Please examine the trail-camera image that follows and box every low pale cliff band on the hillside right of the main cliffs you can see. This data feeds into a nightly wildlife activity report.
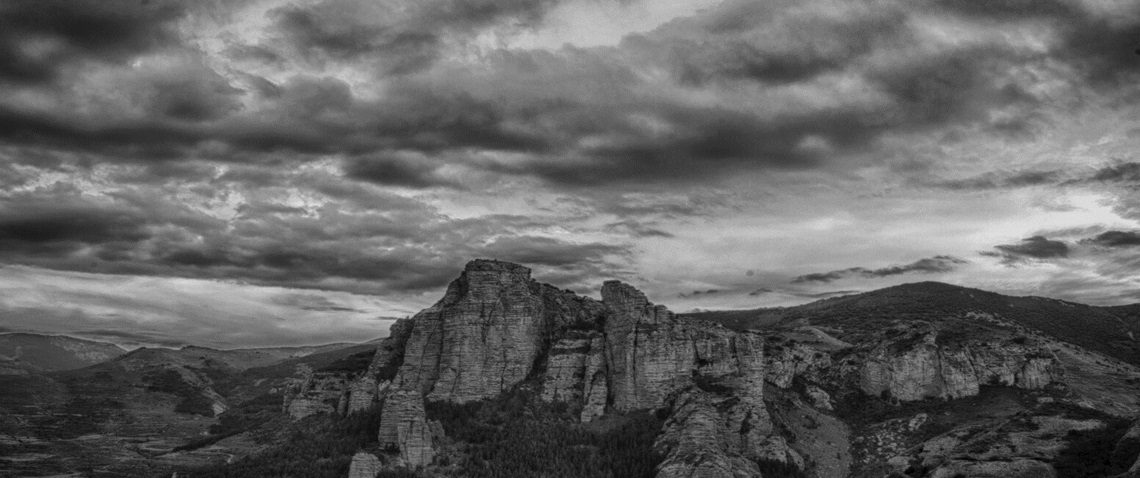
[860,332,1060,400]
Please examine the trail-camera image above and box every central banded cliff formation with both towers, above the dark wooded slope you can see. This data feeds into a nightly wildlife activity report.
[367,260,793,474]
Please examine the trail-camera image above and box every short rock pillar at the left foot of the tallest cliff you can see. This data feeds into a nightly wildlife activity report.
[378,390,435,468]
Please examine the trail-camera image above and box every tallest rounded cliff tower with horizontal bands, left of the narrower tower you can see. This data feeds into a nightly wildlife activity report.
[393,260,601,403]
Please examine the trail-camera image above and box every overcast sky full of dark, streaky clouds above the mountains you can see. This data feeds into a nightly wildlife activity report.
[0,0,1140,347]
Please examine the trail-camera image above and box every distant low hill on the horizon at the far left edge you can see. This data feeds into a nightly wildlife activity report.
[0,333,127,375]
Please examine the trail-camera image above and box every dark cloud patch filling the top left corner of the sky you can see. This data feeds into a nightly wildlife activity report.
[0,0,185,82]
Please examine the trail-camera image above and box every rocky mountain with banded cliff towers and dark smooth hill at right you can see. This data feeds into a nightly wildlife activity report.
[337,261,1140,477]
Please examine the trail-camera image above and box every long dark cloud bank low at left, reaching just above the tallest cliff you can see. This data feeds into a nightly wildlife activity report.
[0,173,629,296]
